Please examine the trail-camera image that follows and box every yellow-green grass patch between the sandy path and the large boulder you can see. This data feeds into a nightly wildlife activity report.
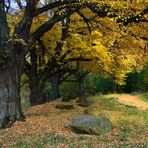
[85,96,148,126]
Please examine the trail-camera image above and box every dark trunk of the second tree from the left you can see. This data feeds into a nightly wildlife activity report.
[25,47,46,106]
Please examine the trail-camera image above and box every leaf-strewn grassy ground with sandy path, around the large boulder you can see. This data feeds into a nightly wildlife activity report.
[0,94,148,148]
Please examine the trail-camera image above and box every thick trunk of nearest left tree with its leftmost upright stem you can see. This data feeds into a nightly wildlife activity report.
[0,1,23,127]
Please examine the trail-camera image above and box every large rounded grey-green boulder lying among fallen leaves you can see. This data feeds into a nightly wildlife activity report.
[70,115,112,135]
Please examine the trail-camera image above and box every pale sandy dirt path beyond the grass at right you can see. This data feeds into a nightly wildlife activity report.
[108,94,148,110]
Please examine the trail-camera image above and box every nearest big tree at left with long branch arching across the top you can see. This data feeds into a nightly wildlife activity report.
[0,0,148,126]
